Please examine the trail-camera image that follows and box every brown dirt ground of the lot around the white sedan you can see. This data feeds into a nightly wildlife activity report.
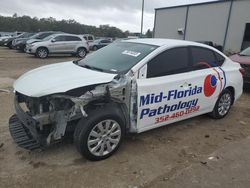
[0,47,250,188]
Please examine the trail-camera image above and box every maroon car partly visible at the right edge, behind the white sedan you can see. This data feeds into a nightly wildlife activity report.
[230,47,250,84]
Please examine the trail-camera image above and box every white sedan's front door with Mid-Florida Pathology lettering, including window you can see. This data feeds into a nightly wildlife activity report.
[137,47,222,132]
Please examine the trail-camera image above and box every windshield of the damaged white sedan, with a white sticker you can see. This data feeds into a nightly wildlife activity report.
[78,42,157,73]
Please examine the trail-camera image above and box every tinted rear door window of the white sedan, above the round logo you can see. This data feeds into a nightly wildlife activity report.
[191,47,217,70]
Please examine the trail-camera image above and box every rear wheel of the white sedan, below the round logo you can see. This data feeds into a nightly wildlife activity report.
[210,89,233,119]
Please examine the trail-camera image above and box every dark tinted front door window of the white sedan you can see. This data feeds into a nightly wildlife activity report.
[147,47,189,78]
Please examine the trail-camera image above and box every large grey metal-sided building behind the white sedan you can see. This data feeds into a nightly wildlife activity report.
[154,0,250,52]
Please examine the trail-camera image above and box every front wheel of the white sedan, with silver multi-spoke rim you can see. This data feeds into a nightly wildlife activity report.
[74,106,125,161]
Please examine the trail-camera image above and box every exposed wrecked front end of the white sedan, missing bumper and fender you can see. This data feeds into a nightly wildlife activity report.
[9,75,135,150]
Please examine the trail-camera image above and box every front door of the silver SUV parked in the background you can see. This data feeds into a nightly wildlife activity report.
[49,35,66,53]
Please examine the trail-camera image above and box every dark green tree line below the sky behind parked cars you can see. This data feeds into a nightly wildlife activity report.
[0,14,152,38]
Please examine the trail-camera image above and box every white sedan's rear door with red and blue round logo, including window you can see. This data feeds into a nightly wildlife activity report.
[189,46,225,112]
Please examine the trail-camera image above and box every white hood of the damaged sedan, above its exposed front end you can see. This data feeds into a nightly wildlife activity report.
[13,62,116,97]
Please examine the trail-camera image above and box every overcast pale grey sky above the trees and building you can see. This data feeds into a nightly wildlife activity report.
[0,0,218,32]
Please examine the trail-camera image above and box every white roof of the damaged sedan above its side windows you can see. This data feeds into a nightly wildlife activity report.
[122,38,211,48]
